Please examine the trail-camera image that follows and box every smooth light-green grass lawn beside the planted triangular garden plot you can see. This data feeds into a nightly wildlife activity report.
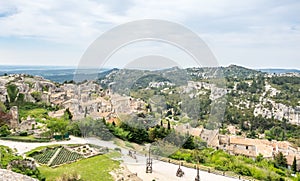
[39,155,120,181]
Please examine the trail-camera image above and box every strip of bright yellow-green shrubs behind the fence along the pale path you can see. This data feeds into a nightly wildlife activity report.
[170,148,290,180]
